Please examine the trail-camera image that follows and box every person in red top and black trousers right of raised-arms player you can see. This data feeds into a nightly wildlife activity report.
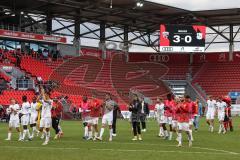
[51,99,63,139]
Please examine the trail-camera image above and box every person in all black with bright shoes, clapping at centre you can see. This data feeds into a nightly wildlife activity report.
[129,94,142,141]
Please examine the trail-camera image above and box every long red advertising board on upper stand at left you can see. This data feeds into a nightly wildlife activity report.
[0,29,67,43]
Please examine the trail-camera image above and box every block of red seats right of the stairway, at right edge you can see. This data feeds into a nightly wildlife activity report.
[192,62,240,96]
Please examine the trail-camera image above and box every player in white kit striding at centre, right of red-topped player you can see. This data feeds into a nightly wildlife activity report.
[97,94,115,141]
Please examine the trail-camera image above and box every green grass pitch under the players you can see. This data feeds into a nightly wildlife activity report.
[0,118,240,160]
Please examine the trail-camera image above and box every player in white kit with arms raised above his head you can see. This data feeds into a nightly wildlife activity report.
[39,88,53,145]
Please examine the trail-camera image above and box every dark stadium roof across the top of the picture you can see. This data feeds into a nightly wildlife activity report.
[0,0,240,32]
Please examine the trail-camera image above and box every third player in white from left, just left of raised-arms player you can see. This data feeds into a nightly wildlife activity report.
[30,97,39,139]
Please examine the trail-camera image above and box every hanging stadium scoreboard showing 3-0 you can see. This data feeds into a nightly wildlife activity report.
[160,24,206,52]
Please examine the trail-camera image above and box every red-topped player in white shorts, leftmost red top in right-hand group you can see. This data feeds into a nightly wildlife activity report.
[164,94,175,140]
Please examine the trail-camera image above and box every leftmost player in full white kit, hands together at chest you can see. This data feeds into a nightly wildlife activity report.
[6,98,22,141]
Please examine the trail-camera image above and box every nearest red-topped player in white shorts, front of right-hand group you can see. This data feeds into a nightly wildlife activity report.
[176,95,192,147]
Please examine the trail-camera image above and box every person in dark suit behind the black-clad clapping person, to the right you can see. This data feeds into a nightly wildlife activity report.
[140,97,150,132]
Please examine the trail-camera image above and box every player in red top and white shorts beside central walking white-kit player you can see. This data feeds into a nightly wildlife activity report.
[88,98,102,140]
